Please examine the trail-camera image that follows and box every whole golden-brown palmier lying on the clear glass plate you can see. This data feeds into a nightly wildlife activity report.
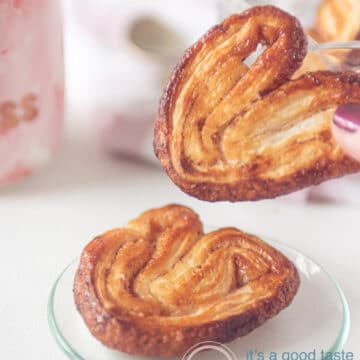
[74,205,299,357]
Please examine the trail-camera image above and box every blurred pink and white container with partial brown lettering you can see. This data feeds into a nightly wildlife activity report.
[0,0,64,185]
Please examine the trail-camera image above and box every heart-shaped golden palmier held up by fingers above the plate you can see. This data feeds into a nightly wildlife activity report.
[154,6,360,201]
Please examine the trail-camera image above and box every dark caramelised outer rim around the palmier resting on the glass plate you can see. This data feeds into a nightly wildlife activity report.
[74,205,300,357]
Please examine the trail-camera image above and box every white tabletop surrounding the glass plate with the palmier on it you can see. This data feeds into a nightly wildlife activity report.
[0,1,360,360]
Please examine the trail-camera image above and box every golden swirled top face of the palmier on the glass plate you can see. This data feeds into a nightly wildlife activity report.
[82,206,296,324]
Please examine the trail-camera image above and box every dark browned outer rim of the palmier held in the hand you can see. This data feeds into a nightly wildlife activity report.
[154,6,360,202]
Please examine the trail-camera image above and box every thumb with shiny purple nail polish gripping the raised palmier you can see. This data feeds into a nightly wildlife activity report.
[332,104,360,161]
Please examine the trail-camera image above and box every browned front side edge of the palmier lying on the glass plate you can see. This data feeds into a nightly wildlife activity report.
[74,268,300,357]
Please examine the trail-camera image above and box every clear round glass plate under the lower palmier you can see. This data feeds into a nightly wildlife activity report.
[48,241,350,360]
